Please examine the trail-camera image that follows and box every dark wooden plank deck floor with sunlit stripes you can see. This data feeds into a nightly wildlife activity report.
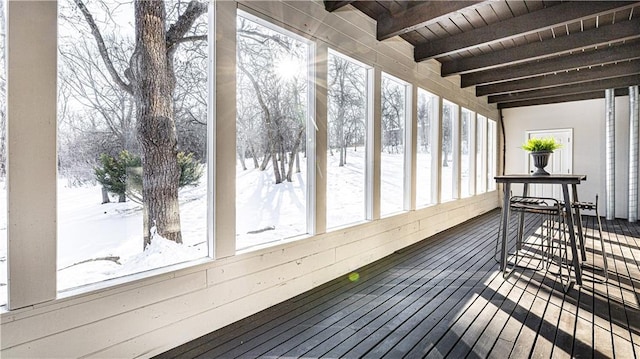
[158,210,640,359]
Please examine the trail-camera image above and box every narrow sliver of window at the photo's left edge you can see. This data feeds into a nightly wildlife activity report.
[0,0,8,306]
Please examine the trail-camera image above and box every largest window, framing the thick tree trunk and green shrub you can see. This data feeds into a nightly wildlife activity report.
[57,0,212,290]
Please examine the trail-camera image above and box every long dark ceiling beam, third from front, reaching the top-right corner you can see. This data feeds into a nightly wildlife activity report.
[414,1,640,61]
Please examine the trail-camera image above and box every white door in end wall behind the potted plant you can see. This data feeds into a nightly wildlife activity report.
[525,129,573,200]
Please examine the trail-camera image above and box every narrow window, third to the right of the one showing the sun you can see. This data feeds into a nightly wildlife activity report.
[416,89,439,208]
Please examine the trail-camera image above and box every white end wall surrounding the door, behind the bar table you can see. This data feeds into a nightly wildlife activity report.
[503,96,629,218]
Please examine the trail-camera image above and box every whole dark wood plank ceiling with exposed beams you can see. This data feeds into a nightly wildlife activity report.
[324,0,640,108]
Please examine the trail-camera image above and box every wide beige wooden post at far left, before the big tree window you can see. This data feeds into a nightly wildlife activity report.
[7,1,58,310]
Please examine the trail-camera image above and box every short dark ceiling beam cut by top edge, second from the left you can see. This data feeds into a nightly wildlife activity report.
[376,0,487,41]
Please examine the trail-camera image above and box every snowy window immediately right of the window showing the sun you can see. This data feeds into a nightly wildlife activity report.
[326,51,370,228]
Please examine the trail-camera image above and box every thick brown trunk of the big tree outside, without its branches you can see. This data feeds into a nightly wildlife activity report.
[130,1,182,248]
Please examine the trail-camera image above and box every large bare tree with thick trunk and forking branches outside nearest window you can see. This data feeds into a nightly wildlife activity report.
[74,0,207,247]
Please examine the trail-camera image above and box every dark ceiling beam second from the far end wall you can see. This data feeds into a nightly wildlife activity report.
[487,75,640,103]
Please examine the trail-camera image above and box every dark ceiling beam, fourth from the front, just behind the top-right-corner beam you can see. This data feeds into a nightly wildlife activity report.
[441,18,640,76]
